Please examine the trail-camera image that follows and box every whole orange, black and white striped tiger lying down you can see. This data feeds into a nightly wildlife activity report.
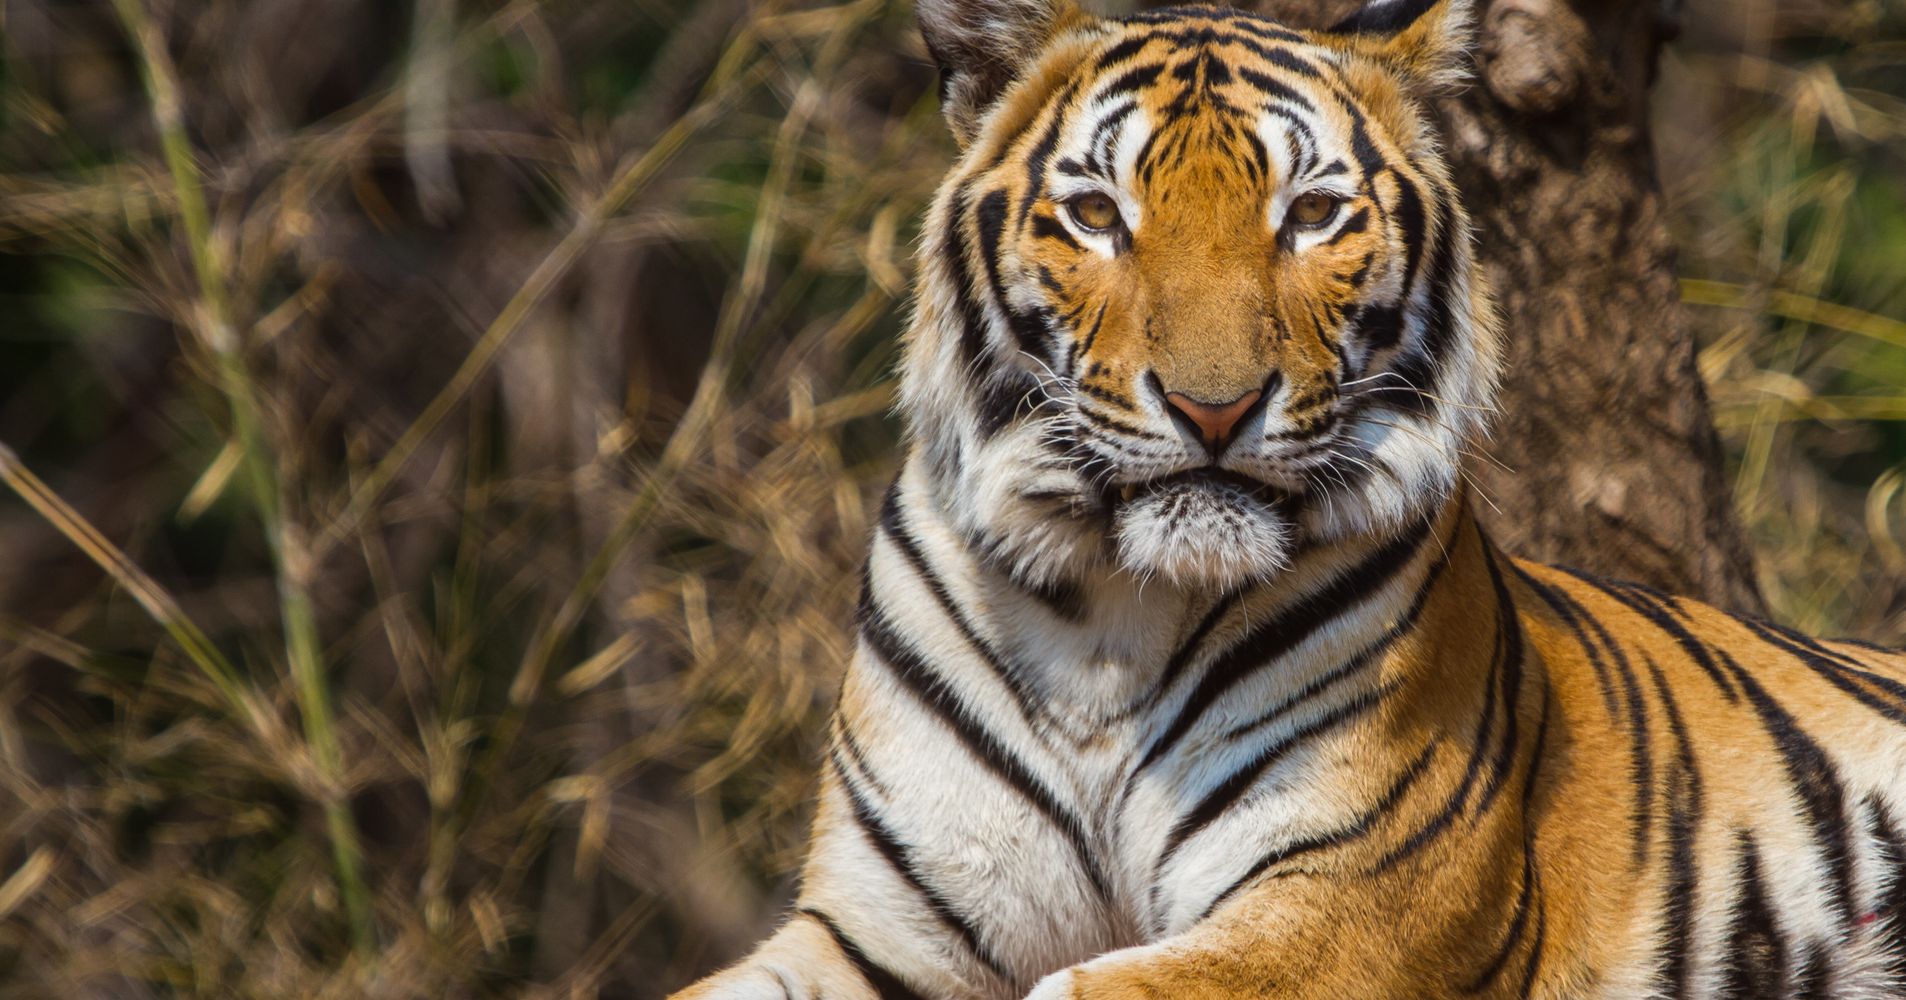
[677,0,1906,1000]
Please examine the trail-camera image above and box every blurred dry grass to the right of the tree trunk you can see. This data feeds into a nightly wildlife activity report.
[1656,2,1906,644]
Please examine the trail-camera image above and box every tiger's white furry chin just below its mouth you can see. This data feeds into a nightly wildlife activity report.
[1117,482,1296,587]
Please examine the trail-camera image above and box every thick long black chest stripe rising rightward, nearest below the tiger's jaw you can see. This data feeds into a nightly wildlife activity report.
[1132,518,1431,777]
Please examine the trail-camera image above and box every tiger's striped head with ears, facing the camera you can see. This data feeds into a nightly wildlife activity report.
[902,0,1500,587]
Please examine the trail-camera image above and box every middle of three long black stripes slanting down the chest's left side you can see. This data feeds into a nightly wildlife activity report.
[860,598,1107,897]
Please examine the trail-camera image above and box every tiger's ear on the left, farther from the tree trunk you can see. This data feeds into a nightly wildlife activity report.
[915,0,1081,147]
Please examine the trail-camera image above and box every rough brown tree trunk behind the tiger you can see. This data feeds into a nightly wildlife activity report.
[1212,0,1765,613]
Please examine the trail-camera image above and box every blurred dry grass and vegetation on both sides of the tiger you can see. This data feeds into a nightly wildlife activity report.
[0,0,1906,1000]
